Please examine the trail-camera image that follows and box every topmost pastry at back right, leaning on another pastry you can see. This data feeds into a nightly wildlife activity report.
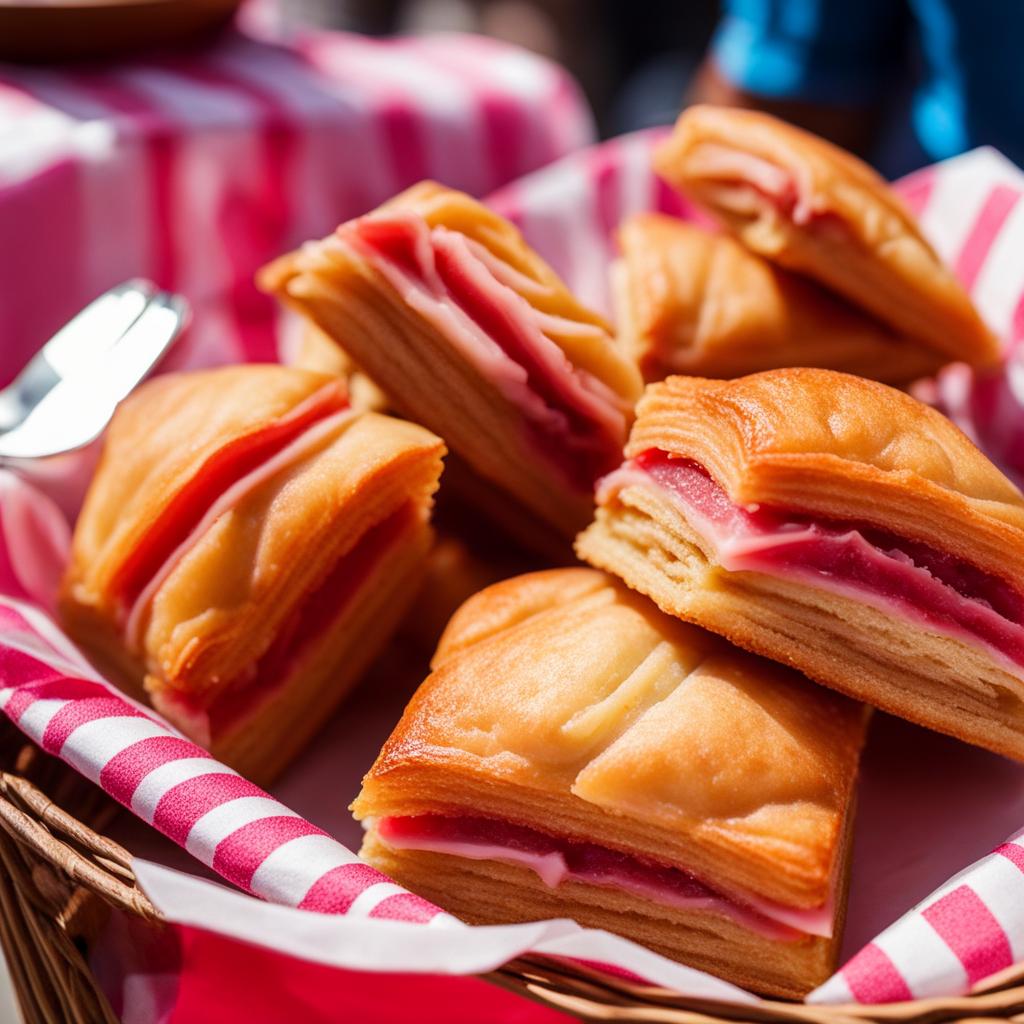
[654,106,998,366]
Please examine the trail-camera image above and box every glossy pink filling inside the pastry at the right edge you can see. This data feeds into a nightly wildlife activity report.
[599,450,1024,672]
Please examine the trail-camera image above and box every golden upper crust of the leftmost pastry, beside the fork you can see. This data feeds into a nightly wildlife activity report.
[60,367,443,707]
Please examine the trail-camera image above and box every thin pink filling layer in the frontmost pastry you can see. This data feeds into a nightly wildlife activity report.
[377,814,834,942]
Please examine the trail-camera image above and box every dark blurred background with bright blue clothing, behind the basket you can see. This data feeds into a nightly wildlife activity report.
[266,0,1024,177]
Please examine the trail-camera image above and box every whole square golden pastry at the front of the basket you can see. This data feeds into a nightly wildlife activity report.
[352,568,866,996]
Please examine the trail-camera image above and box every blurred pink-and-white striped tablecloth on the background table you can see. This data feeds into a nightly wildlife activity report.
[0,24,593,384]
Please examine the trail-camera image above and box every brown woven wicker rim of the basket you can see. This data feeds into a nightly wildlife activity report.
[0,743,1024,1024]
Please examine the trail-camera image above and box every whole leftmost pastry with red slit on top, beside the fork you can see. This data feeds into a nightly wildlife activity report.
[60,366,443,784]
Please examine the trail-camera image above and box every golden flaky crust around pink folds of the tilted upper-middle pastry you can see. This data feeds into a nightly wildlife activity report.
[260,182,642,537]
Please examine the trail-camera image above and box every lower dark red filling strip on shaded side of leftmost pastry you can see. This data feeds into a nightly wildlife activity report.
[154,505,416,745]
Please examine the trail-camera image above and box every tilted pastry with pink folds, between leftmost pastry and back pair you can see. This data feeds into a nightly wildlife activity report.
[260,182,641,537]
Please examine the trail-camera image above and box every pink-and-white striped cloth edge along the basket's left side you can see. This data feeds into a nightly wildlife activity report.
[0,479,451,923]
